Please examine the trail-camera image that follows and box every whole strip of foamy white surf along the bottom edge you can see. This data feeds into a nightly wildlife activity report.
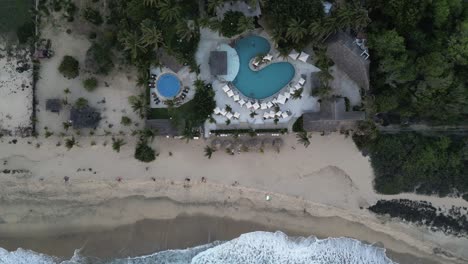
[0,232,394,264]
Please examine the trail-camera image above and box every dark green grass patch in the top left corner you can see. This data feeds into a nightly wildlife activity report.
[0,0,34,33]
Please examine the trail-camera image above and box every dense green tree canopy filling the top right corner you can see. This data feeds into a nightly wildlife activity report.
[367,0,468,124]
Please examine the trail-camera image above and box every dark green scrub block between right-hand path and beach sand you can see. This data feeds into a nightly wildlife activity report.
[366,133,468,196]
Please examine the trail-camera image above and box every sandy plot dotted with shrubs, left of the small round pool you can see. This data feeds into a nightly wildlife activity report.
[37,23,144,135]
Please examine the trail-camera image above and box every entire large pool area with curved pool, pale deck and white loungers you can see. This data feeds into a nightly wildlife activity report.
[197,30,319,137]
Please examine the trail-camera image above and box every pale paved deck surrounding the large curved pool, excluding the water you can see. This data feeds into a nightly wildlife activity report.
[196,28,320,137]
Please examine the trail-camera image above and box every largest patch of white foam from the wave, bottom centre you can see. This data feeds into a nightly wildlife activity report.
[192,232,393,264]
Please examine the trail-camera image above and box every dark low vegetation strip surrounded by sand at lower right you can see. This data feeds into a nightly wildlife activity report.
[368,199,468,236]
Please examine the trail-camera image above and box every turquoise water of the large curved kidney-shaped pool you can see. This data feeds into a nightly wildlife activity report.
[233,36,295,99]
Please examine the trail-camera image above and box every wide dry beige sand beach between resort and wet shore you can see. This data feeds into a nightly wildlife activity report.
[0,134,468,263]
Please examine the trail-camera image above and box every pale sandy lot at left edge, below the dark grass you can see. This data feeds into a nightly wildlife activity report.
[0,44,33,136]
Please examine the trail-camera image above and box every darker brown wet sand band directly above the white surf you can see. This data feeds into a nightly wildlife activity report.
[0,207,440,264]
